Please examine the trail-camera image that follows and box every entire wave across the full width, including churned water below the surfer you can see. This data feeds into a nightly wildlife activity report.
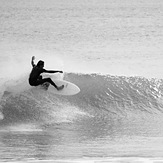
[0,73,163,126]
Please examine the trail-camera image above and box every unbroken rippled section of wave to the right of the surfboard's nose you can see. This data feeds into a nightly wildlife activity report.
[65,74,163,115]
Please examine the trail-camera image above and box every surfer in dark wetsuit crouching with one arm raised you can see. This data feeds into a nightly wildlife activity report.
[29,56,64,91]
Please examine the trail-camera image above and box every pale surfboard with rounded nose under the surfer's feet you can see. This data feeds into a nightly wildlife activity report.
[41,79,80,96]
